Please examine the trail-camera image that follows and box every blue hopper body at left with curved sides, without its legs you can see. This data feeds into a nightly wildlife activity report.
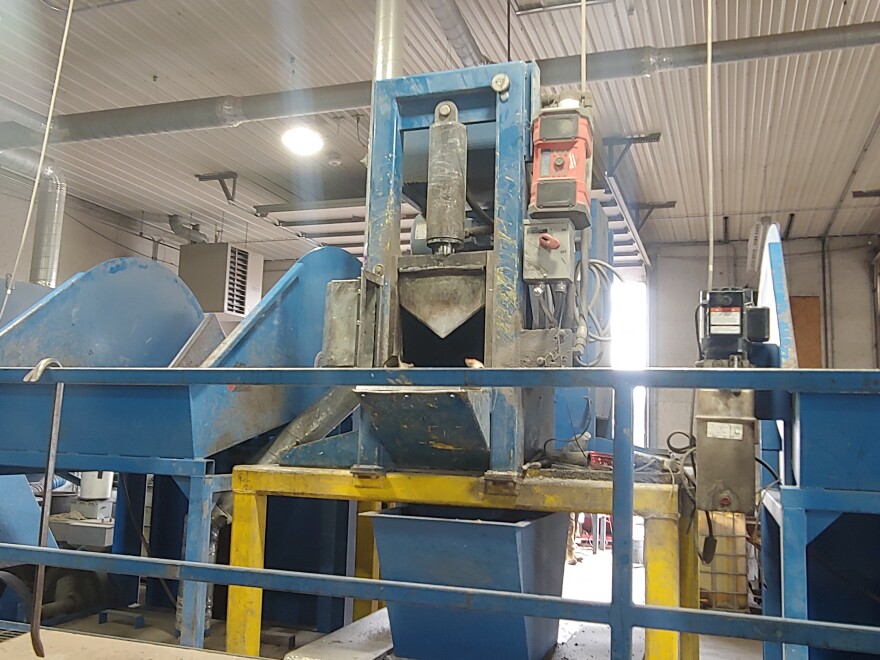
[0,248,359,469]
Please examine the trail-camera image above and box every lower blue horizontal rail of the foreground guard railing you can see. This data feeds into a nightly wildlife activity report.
[0,543,880,652]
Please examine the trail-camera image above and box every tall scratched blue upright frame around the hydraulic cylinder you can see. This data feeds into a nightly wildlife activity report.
[358,62,540,474]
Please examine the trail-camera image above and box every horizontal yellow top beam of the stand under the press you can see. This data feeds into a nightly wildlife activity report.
[232,465,678,519]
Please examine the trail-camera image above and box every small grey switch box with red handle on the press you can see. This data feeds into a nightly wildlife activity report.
[523,218,577,284]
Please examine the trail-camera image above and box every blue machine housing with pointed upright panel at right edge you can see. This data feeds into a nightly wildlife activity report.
[758,226,880,660]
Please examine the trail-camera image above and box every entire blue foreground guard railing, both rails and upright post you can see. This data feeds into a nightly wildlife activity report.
[0,368,880,660]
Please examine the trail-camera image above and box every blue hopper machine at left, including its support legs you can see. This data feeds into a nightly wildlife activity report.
[0,247,360,646]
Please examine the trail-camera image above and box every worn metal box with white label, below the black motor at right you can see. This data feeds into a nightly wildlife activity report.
[694,390,758,513]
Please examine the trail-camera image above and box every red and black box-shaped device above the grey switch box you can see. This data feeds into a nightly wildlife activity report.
[529,102,593,229]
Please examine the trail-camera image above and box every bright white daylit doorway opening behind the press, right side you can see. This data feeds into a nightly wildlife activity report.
[611,280,648,447]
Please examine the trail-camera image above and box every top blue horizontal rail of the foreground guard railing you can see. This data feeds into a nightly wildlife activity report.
[0,367,880,394]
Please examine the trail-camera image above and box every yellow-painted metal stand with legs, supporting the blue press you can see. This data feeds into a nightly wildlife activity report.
[226,466,699,660]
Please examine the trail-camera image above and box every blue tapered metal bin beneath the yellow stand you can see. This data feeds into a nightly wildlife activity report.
[362,505,569,660]
